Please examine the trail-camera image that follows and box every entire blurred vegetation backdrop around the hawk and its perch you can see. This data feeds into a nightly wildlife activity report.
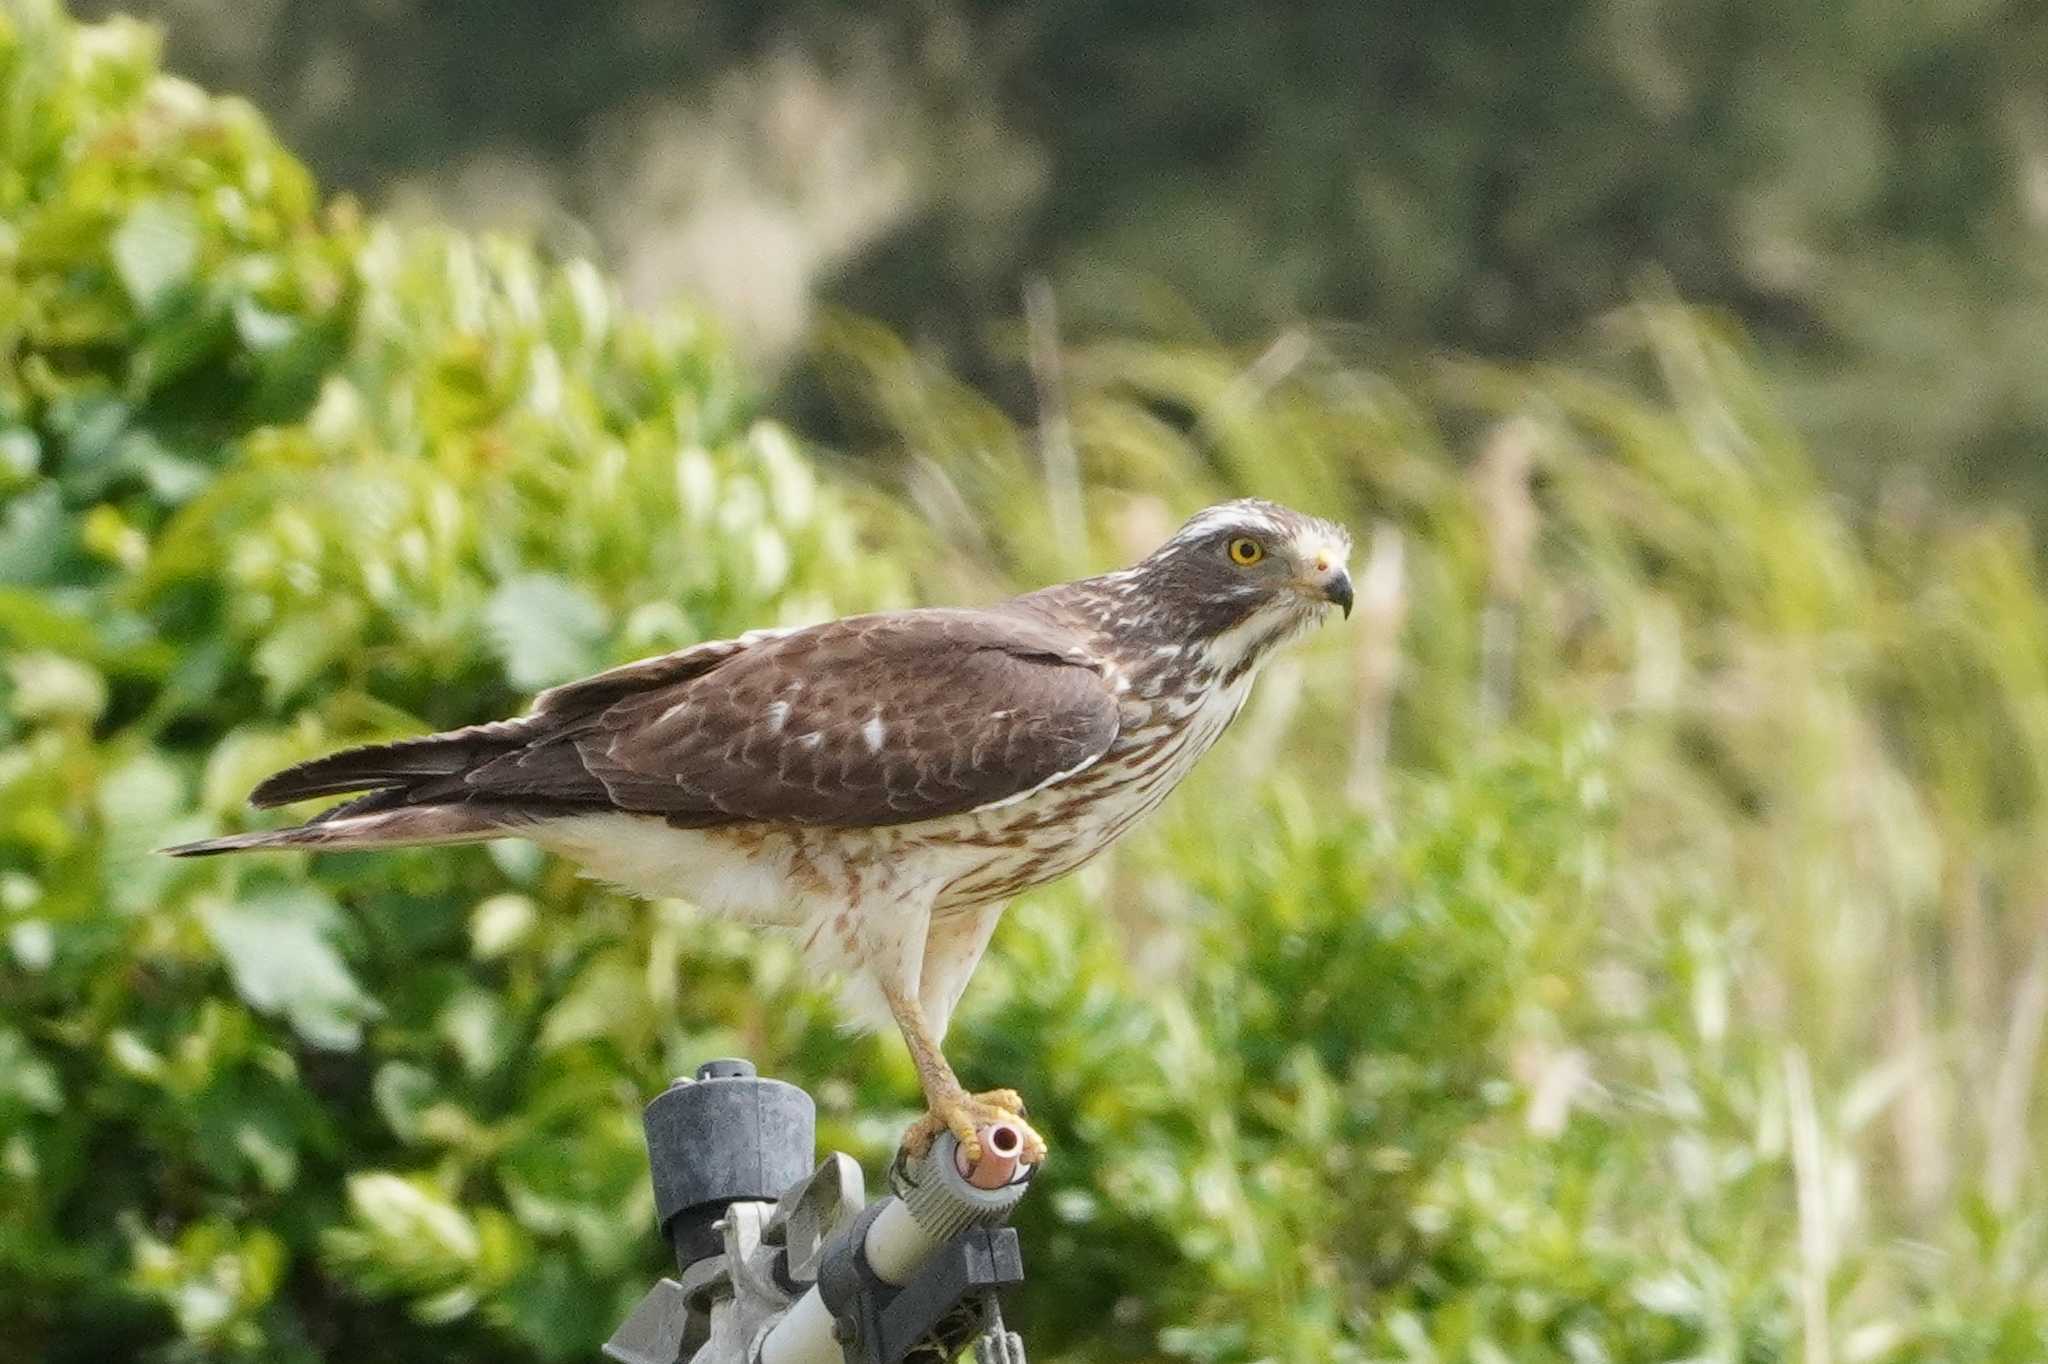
[0,0,2048,1364]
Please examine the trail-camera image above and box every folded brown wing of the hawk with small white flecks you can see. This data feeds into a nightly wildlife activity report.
[262,610,1116,825]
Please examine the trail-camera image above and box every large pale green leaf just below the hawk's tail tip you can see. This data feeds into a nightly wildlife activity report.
[201,885,381,1051]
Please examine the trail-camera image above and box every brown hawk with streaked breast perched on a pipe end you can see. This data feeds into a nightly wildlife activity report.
[170,500,1352,1159]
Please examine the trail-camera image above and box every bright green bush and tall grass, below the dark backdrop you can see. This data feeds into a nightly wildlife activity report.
[0,0,2048,1364]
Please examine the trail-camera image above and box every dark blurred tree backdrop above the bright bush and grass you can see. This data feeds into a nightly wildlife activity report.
[64,0,2048,514]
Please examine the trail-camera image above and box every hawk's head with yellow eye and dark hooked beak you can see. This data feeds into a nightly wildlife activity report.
[1130,498,1352,666]
